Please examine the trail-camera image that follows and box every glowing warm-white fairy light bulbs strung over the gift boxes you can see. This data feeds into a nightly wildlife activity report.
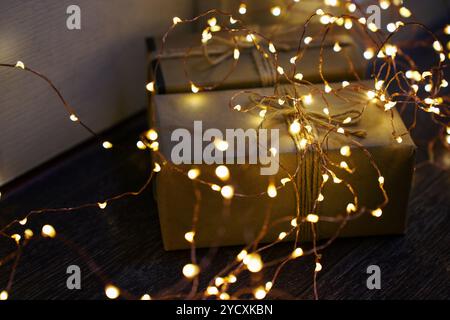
[0,0,450,300]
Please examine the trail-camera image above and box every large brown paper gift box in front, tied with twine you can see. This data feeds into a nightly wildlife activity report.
[153,82,415,250]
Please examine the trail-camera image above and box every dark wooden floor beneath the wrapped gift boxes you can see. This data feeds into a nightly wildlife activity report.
[0,110,450,299]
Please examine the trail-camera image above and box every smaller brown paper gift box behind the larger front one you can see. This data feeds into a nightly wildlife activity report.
[147,29,367,94]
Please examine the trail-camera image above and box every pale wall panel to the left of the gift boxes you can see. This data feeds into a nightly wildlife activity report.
[0,0,193,185]
